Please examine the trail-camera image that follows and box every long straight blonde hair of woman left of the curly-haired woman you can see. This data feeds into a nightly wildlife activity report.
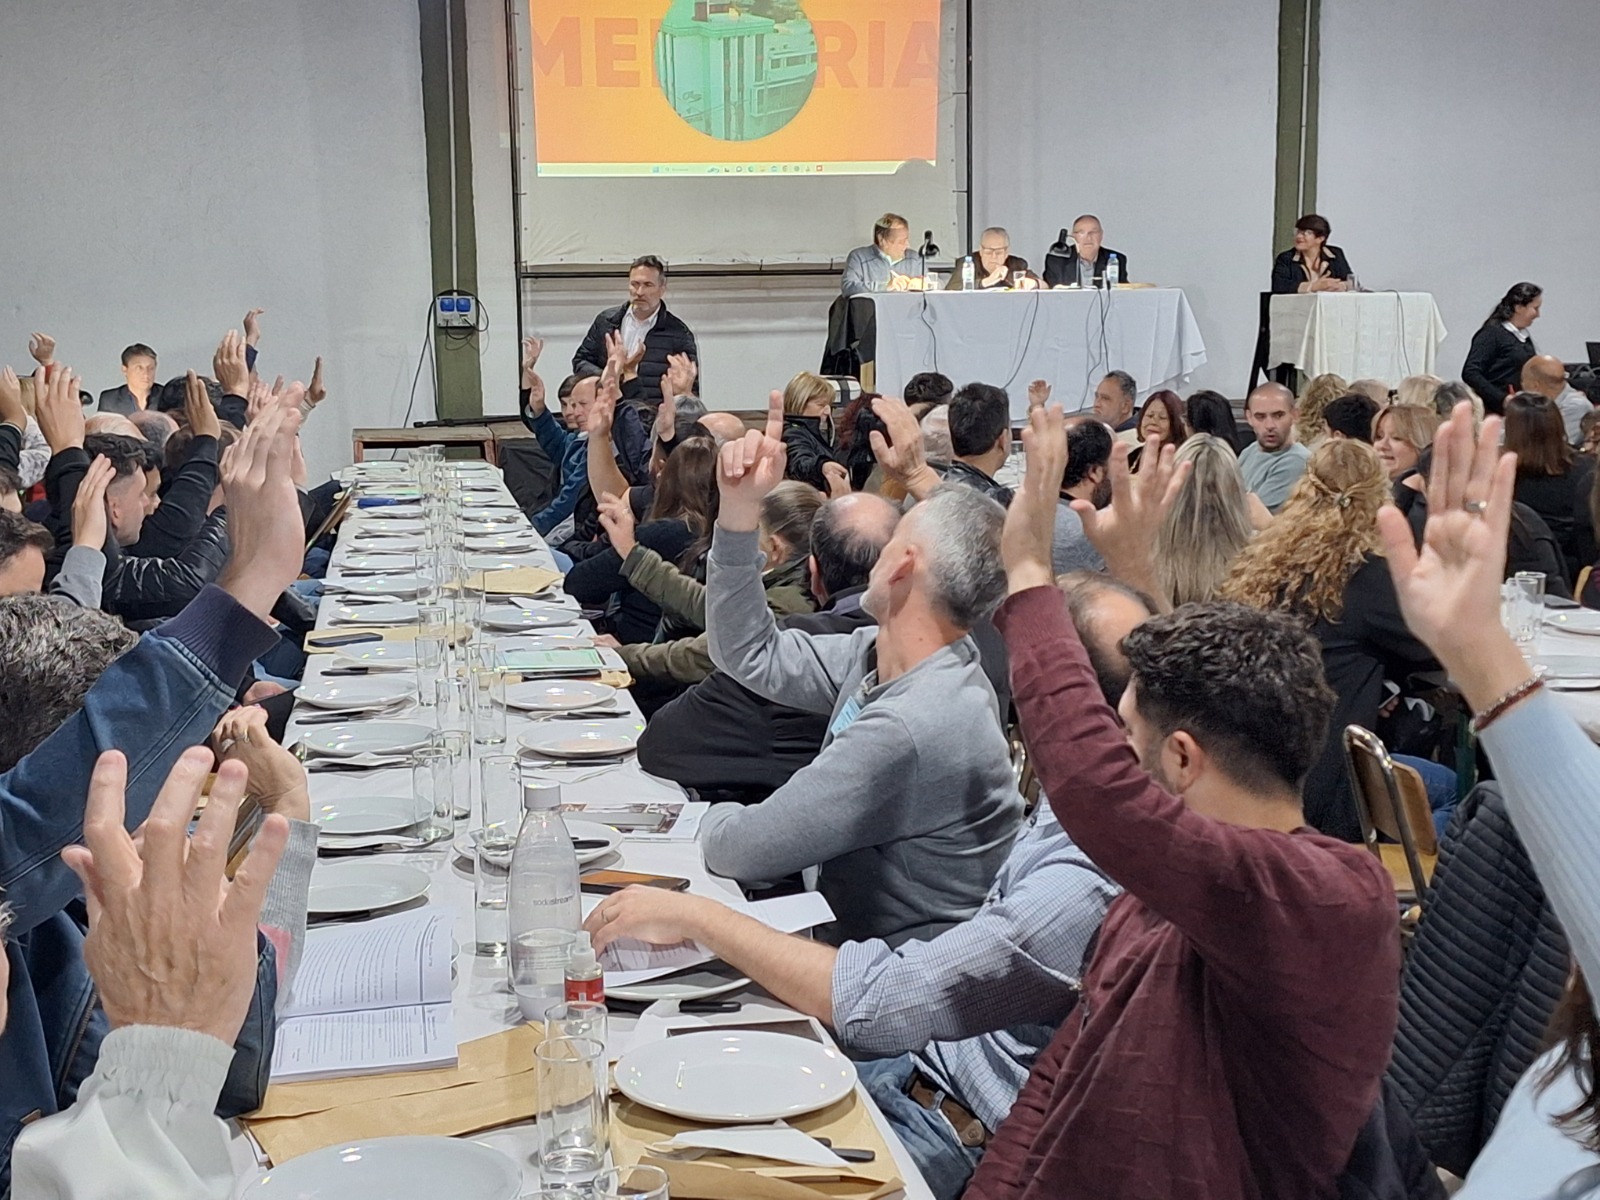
[1154,434,1256,608]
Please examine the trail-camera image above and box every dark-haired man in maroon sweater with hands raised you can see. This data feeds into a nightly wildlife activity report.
[966,410,1400,1200]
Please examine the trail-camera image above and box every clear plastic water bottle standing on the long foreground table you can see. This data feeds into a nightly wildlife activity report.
[506,781,582,1021]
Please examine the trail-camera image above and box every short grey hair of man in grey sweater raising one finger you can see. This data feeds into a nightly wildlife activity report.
[910,483,1005,629]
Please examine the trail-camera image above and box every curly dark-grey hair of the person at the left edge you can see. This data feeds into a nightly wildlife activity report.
[0,592,139,771]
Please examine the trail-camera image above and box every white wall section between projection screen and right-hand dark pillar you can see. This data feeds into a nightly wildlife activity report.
[973,0,1280,395]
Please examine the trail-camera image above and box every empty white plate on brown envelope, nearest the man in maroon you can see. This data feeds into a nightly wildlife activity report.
[616,1029,856,1123]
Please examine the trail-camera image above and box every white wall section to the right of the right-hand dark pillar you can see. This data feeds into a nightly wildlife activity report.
[1317,0,1600,376]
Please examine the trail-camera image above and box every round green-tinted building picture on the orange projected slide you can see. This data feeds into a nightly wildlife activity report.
[656,0,816,142]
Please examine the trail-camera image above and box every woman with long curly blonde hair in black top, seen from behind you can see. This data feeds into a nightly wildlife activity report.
[1222,438,1437,842]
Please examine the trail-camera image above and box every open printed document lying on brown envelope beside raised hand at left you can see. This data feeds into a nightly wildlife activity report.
[272,909,456,1080]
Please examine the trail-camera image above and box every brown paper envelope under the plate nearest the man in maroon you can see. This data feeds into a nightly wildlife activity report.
[611,1091,904,1200]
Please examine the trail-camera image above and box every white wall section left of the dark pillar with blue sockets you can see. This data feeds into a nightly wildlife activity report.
[0,0,432,483]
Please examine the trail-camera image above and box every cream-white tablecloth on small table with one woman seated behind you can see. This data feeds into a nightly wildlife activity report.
[1267,291,1445,384]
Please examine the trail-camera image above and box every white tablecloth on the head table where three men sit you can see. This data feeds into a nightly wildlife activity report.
[872,288,1205,418]
